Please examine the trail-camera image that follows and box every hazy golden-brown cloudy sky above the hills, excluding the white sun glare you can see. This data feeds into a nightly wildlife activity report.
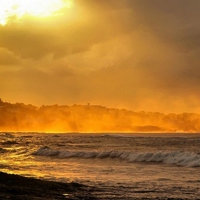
[0,0,200,112]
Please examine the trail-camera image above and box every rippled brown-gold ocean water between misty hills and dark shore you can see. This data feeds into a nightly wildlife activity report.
[0,132,200,200]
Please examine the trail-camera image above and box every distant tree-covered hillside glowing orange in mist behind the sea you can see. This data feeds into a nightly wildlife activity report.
[0,99,200,132]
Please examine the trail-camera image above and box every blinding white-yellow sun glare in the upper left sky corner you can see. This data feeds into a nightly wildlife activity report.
[0,0,73,25]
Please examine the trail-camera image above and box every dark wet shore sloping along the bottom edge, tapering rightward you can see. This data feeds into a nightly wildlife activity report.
[0,172,193,200]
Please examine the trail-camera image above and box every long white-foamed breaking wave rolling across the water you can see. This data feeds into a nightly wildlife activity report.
[33,146,200,167]
